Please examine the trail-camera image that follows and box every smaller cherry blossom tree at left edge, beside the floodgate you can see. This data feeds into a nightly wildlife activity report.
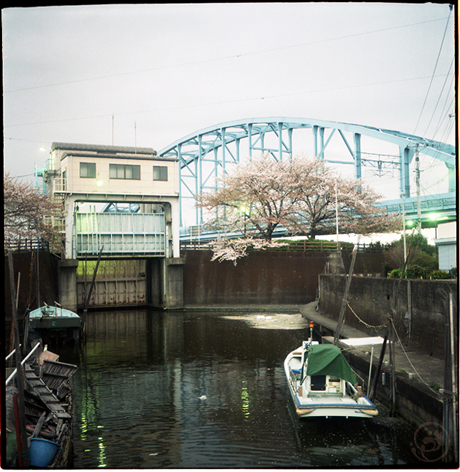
[3,174,62,248]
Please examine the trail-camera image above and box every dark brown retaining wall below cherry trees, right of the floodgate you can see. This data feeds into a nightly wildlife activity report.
[184,250,383,306]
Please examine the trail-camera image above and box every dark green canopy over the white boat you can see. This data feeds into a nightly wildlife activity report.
[306,344,356,385]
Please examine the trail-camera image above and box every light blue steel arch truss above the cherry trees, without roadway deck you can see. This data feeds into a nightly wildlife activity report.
[159,117,456,226]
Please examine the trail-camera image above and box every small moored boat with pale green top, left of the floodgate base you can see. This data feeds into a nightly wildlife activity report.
[28,305,81,343]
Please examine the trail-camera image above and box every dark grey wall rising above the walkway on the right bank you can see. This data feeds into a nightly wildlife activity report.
[318,274,458,358]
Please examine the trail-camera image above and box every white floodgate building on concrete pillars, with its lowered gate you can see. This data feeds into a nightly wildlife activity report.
[36,143,183,311]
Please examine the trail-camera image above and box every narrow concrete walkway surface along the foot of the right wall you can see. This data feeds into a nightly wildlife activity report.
[300,302,445,391]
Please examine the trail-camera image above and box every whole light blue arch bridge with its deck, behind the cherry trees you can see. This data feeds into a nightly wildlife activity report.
[155,117,456,237]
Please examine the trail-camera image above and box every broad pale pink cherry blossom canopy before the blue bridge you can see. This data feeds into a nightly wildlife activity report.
[197,155,400,242]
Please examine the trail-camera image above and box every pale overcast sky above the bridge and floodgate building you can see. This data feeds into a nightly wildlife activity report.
[2,2,456,201]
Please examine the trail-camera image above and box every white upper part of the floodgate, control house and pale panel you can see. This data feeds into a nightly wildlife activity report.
[44,143,180,259]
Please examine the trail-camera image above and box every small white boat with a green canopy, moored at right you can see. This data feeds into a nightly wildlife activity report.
[284,326,378,418]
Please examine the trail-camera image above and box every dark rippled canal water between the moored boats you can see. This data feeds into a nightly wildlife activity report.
[56,310,424,469]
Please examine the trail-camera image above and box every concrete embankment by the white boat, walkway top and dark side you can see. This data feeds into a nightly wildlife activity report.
[300,302,445,426]
